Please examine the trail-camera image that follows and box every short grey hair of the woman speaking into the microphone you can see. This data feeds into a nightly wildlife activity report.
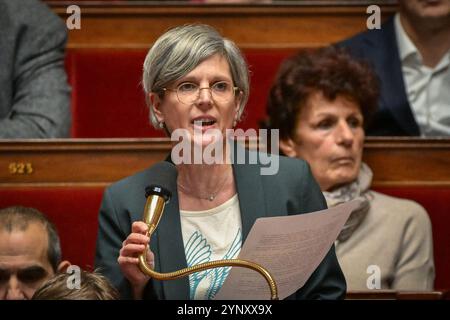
[142,24,250,128]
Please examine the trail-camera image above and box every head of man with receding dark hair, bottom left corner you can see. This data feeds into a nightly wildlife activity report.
[0,207,70,300]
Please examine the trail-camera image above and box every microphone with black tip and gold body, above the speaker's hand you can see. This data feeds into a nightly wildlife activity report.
[143,161,178,235]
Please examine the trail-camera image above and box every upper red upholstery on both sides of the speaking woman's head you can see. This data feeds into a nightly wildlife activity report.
[66,49,294,138]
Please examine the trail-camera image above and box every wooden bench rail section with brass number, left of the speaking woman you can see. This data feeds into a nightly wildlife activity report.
[0,139,170,186]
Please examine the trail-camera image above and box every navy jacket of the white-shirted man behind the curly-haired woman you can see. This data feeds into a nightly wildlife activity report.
[337,18,420,136]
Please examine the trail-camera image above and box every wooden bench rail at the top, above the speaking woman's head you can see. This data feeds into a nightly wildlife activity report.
[49,1,395,48]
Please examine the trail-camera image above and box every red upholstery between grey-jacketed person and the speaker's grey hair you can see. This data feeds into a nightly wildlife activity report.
[66,49,164,138]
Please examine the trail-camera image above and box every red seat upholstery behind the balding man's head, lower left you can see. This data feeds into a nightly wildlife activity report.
[0,187,103,270]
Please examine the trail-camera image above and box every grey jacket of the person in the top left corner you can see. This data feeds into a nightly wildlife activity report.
[0,0,71,139]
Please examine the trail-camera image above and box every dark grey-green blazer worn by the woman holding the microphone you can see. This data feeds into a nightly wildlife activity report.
[95,151,346,300]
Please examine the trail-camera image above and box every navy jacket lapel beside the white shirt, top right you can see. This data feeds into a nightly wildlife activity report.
[366,18,420,135]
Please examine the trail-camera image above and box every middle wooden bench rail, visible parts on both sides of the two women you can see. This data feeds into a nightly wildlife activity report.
[0,138,450,187]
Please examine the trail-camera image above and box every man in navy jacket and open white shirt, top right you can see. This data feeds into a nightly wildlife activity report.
[339,0,450,136]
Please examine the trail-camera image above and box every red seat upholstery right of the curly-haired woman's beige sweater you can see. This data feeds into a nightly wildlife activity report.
[376,187,450,289]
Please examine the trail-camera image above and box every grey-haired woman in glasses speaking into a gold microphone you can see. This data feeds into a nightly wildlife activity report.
[96,25,346,300]
